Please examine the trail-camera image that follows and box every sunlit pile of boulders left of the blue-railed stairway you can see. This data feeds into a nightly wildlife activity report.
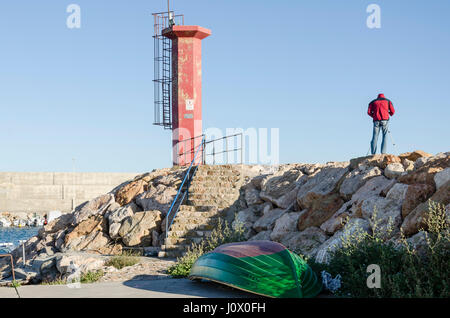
[0,168,186,283]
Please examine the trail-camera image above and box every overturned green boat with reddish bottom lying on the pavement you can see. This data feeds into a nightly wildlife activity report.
[189,241,322,298]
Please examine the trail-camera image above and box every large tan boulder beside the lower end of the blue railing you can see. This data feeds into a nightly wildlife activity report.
[119,210,162,246]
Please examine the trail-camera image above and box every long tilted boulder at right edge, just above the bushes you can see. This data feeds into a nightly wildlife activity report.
[401,181,450,236]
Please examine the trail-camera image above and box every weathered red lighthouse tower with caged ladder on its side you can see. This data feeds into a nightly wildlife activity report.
[153,3,211,166]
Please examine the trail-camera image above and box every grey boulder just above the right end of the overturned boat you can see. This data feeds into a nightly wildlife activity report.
[281,227,328,258]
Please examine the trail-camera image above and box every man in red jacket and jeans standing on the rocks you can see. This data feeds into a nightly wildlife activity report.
[367,94,395,155]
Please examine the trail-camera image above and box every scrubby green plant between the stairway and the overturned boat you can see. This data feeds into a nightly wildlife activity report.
[167,219,245,277]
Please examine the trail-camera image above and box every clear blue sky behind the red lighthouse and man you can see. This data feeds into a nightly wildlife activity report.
[0,0,450,172]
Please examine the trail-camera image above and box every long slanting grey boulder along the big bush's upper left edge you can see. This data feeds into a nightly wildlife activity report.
[315,218,370,263]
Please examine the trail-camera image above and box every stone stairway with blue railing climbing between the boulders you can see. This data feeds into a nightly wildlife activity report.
[158,165,242,257]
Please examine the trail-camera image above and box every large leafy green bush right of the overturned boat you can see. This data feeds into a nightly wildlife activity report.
[311,202,450,298]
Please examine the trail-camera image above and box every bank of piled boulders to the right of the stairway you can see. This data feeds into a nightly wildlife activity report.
[234,151,450,262]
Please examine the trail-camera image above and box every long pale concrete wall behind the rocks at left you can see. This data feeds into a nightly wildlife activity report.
[0,172,138,214]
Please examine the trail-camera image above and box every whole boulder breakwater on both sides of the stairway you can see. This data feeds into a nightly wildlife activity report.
[0,151,450,283]
